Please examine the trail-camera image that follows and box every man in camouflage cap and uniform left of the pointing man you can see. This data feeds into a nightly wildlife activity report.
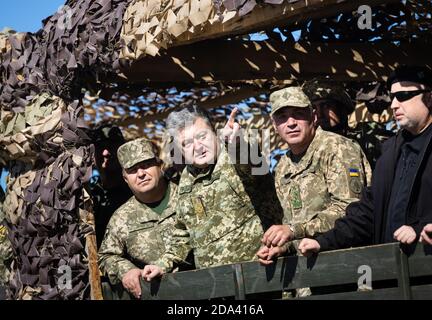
[99,138,181,297]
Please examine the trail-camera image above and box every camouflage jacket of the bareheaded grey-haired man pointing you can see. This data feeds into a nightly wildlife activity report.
[156,148,283,271]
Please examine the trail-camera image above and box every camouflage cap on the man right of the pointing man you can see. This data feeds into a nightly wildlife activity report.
[270,87,311,115]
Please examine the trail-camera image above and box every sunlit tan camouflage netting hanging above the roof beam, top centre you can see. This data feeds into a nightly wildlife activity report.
[120,0,299,60]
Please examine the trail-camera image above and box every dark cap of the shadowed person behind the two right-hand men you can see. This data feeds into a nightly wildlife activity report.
[303,80,355,114]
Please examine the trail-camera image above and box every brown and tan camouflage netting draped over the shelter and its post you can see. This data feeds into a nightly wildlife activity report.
[0,0,432,299]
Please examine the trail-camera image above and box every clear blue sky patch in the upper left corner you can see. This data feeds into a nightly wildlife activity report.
[0,0,66,32]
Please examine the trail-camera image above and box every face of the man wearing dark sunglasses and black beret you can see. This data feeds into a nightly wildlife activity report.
[391,81,432,134]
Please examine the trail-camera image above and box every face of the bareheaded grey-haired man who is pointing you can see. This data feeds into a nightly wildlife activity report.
[176,118,218,168]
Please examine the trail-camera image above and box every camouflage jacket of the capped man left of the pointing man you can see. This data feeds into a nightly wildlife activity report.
[99,183,177,284]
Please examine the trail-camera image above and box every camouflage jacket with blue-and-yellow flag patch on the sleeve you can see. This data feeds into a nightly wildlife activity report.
[275,127,371,239]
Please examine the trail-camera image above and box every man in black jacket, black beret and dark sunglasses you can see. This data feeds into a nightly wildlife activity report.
[296,66,432,255]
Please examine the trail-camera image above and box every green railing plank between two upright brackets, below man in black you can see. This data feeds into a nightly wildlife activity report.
[243,244,397,294]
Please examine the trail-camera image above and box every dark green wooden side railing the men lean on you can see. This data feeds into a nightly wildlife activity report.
[138,243,432,300]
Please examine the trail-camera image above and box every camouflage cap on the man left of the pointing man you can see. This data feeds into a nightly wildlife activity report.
[117,138,158,169]
